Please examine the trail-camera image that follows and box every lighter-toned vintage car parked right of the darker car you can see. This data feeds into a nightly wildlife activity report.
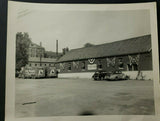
[105,71,129,80]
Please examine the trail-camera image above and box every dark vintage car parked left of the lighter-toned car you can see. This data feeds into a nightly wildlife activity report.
[92,71,109,80]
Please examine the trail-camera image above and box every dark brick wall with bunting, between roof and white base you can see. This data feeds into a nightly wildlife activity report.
[56,52,152,73]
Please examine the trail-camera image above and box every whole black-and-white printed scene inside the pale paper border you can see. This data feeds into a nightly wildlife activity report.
[5,1,158,121]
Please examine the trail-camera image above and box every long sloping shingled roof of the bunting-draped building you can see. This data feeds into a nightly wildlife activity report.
[57,35,151,62]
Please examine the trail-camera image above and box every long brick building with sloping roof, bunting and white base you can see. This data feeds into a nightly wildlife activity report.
[56,35,153,79]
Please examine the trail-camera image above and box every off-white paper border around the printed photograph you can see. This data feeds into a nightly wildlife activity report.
[5,1,160,121]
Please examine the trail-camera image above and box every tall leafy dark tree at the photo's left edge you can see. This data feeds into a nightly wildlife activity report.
[16,32,31,71]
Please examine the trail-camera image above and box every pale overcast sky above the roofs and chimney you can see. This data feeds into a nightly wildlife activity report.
[17,10,150,52]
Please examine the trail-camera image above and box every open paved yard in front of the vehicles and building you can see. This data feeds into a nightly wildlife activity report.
[16,78,154,117]
